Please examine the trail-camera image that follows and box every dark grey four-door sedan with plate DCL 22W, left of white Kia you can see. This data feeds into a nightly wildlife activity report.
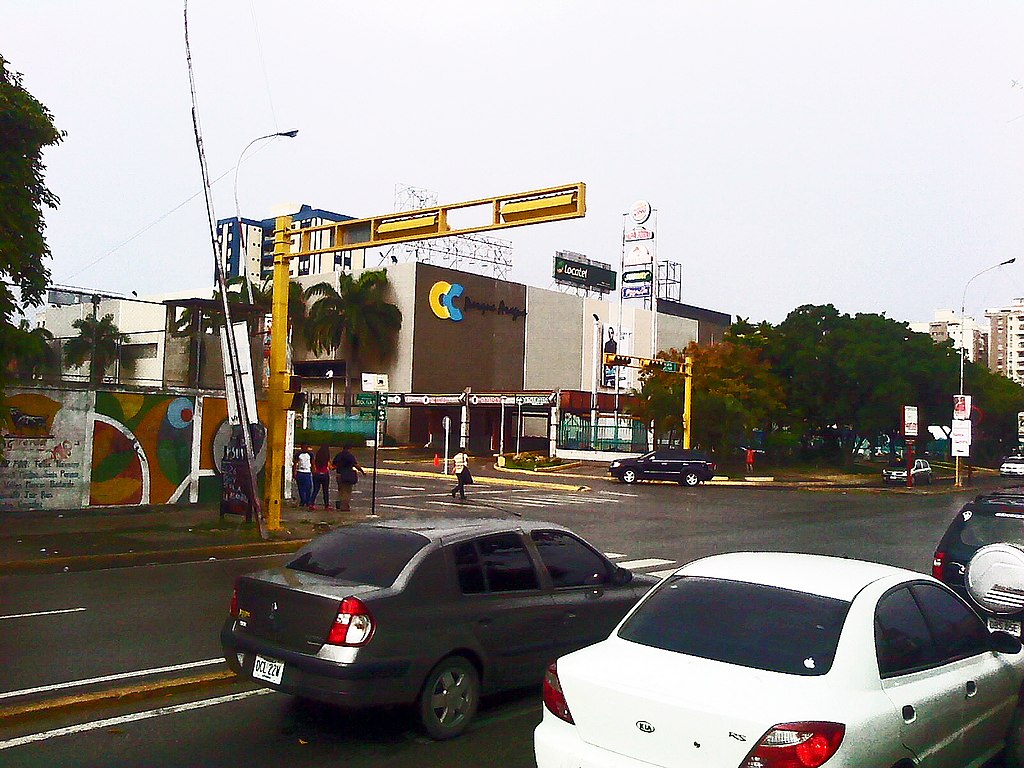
[220,519,657,739]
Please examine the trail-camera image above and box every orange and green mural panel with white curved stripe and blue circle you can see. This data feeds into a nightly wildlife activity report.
[89,391,196,506]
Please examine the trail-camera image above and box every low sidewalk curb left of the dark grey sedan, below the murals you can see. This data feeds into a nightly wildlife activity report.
[0,539,309,574]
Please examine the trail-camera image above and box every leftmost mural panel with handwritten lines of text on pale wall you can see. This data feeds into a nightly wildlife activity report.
[0,390,88,509]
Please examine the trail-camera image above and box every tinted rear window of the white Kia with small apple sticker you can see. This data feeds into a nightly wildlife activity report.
[618,575,850,676]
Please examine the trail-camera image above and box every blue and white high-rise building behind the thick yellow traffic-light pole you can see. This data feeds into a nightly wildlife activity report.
[217,205,362,283]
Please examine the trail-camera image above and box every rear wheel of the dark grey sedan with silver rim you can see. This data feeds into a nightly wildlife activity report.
[419,656,480,740]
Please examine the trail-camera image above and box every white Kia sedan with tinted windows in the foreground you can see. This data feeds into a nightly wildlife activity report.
[535,553,1024,768]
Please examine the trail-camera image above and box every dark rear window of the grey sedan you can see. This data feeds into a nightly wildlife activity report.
[287,527,429,587]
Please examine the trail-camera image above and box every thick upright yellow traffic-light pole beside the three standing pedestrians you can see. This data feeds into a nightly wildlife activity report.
[264,216,292,530]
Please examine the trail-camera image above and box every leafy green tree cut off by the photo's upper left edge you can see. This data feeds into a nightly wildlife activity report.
[0,56,65,405]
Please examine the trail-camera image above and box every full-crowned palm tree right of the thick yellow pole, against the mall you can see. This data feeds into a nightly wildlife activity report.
[304,269,401,414]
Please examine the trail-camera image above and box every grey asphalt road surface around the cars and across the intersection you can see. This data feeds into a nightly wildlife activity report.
[0,478,991,768]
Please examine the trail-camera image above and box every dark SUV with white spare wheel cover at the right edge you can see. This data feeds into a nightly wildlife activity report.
[932,488,1024,637]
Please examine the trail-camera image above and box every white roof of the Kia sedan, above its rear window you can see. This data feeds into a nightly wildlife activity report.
[679,552,924,601]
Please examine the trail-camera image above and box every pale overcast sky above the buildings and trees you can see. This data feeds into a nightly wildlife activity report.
[8,0,1024,323]
